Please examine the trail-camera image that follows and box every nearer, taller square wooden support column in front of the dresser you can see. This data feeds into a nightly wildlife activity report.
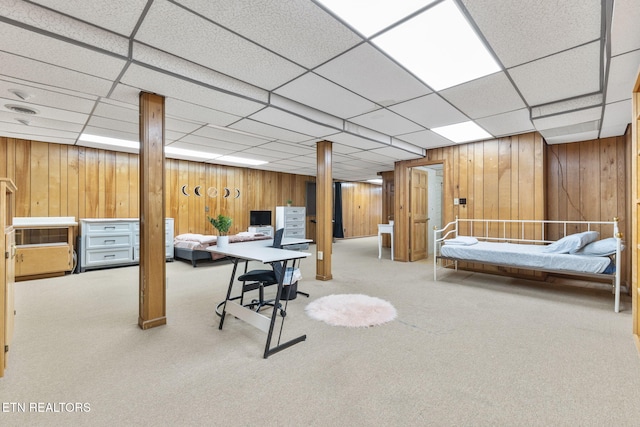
[138,92,167,329]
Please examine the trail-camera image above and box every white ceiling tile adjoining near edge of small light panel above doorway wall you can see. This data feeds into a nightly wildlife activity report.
[389,93,469,128]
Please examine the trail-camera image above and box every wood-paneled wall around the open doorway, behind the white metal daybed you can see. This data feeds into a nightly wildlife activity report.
[395,133,545,261]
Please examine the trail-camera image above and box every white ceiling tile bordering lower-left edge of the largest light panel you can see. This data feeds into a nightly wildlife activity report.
[315,44,431,106]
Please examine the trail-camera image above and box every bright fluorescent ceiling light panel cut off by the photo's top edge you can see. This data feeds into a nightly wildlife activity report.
[319,0,435,37]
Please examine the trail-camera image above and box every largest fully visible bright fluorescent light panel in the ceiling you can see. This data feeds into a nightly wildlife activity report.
[372,0,500,91]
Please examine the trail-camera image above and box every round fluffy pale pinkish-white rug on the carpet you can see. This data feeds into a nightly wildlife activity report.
[304,294,397,328]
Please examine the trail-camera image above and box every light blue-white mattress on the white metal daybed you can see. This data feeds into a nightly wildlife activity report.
[440,242,611,273]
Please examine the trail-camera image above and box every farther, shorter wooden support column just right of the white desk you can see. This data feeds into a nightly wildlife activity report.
[316,141,333,280]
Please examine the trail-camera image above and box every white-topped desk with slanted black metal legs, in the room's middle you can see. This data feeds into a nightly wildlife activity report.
[207,239,311,359]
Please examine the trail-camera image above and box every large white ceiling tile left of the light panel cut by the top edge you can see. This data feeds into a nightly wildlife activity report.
[180,0,362,68]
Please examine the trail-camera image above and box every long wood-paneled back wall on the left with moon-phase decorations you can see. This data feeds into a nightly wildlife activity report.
[0,137,381,242]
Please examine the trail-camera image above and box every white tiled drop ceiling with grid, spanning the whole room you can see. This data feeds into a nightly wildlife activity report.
[0,0,640,181]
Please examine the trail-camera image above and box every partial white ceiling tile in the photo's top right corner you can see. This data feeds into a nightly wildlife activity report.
[611,0,640,56]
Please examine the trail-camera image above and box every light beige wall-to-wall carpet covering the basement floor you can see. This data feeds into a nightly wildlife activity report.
[0,237,640,426]
